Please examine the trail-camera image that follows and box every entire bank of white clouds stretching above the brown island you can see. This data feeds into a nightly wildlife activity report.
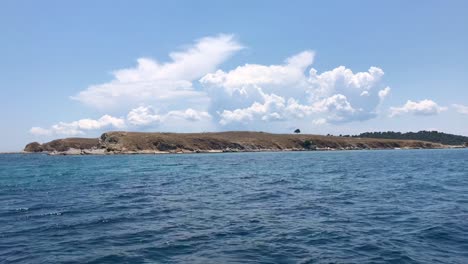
[30,34,432,136]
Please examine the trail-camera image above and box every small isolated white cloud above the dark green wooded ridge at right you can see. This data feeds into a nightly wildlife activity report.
[390,99,447,117]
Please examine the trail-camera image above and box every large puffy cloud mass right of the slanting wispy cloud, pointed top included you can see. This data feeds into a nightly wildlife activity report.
[200,51,390,125]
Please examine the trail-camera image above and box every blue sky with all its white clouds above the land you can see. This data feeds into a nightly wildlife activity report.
[0,0,468,151]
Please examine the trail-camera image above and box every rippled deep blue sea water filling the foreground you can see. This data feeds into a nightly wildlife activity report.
[0,149,468,263]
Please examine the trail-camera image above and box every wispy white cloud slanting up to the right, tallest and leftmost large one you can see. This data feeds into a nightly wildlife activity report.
[72,35,242,110]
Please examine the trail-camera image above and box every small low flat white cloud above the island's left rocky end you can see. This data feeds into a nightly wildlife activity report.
[29,115,125,136]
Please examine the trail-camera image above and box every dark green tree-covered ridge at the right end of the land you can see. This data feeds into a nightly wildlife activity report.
[354,130,468,145]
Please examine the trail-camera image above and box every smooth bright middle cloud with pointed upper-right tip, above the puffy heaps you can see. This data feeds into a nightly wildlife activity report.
[200,51,314,113]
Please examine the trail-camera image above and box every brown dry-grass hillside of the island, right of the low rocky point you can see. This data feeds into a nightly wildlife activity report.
[101,132,442,151]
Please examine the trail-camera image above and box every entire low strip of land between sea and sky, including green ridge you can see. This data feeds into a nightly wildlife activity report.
[24,131,468,155]
